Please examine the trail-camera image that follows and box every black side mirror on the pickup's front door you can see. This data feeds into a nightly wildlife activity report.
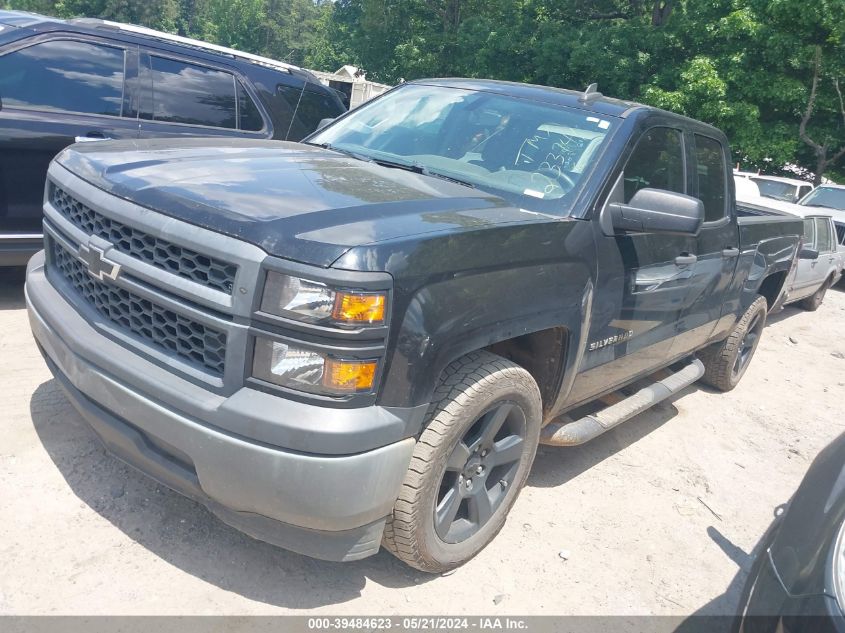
[607,188,704,235]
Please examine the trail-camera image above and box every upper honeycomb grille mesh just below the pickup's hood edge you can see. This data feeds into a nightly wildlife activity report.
[50,184,237,294]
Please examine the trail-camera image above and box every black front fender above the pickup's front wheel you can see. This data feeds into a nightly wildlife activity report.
[335,218,595,406]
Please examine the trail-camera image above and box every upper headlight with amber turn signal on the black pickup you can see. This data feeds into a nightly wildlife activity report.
[261,271,387,325]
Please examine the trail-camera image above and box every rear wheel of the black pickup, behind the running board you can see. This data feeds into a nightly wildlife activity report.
[698,296,767,391]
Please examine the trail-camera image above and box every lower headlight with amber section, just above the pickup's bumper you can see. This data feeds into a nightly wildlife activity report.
[252,337,378,395]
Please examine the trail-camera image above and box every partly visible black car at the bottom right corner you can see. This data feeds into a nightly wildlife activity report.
[736,434,845,633]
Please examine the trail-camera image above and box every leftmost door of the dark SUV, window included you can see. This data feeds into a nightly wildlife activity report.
[0,34,138,233]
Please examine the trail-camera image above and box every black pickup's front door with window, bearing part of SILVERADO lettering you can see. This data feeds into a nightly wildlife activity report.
[568,127,696,404]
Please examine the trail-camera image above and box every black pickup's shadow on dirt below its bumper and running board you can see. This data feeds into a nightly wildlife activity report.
[30,380,695,609]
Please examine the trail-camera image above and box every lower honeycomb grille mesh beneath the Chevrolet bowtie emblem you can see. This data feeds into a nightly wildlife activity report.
[49,239,226,376]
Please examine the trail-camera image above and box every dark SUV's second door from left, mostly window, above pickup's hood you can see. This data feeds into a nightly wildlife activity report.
[139,50,273,138]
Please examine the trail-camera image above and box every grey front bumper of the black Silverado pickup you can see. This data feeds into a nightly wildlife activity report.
[26,249,414,560]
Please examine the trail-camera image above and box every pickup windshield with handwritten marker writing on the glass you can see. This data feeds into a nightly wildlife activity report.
[308,84,615,212]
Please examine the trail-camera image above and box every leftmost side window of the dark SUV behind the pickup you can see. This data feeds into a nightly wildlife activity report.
[0,40,125,117]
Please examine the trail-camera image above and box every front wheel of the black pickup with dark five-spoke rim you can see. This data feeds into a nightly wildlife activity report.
[383,352,542,573]
